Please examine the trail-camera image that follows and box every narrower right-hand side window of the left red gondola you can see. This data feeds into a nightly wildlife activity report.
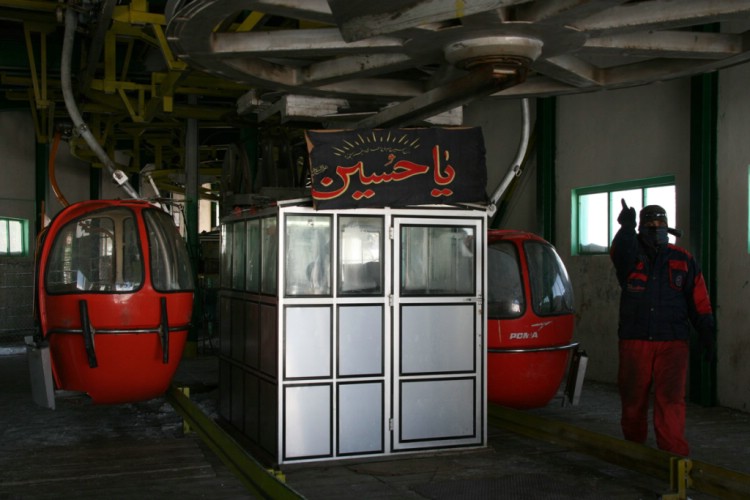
[143,209,193,292]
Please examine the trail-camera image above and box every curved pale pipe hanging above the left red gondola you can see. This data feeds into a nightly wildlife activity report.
[60,7,140,199]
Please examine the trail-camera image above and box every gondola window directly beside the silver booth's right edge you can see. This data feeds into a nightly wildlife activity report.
[487,241,526,319]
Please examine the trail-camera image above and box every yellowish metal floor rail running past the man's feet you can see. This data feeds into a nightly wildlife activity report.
[488,404,750,499]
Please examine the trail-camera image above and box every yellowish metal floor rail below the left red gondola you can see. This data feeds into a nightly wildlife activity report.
[166,387,304,500]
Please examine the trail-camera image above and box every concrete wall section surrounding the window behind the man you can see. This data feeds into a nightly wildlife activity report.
[556,80,690,382]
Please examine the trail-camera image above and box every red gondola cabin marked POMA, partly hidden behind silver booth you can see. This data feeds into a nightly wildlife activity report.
[487,230,577,408]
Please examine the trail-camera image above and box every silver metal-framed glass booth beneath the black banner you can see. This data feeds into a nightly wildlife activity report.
[219,201,487,464]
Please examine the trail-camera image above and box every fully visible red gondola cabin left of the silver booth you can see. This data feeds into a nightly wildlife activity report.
[36,200,193,403]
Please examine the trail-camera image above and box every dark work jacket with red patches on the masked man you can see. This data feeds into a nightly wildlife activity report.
[610,228,714,340]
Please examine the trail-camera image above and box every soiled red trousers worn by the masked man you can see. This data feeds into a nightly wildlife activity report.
[617,340,690,456]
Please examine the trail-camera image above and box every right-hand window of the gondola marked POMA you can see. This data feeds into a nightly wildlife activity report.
[524,241,573,316]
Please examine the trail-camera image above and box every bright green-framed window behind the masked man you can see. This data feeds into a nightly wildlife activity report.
[570,175,677,255]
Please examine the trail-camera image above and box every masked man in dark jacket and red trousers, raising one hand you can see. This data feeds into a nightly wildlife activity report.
[610,200,714,456]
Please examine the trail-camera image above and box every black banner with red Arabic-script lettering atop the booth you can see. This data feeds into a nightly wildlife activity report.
[306,127,487,209]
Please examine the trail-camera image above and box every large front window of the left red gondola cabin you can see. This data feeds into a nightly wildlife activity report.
[46,208,143,293]
